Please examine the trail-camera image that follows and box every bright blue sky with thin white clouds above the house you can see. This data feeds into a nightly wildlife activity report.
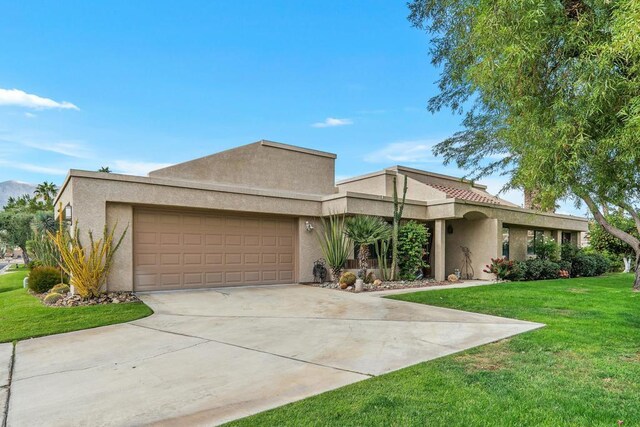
[0,0,580,213]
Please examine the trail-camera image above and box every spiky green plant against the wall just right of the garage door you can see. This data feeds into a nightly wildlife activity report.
[316,214,352,281]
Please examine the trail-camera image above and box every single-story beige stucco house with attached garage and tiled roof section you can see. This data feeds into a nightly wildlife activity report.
[56,141,587,291]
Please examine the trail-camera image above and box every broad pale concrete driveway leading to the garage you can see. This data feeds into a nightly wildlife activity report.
[6,285,541,427]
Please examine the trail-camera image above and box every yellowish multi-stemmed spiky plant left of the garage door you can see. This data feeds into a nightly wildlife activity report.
[49,206,129,298]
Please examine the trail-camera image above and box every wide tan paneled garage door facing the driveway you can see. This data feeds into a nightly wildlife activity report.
[133,209,296,291]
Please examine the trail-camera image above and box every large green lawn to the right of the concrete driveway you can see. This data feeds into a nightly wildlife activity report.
[231,274,640,427]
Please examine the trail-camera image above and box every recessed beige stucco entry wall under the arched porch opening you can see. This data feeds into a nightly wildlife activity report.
[445,219,502,279]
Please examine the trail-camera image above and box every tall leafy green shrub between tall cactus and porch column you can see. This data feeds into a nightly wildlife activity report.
[398,221,429,280]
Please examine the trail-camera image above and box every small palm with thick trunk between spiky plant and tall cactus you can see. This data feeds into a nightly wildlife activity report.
[345,215,391,277]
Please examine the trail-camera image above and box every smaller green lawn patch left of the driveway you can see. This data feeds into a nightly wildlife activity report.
[0,267,152,342]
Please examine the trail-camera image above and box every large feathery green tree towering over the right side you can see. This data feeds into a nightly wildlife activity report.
[409,0,640,290]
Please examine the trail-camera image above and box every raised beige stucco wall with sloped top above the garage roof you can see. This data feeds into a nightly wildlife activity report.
[149,141,336,194]
